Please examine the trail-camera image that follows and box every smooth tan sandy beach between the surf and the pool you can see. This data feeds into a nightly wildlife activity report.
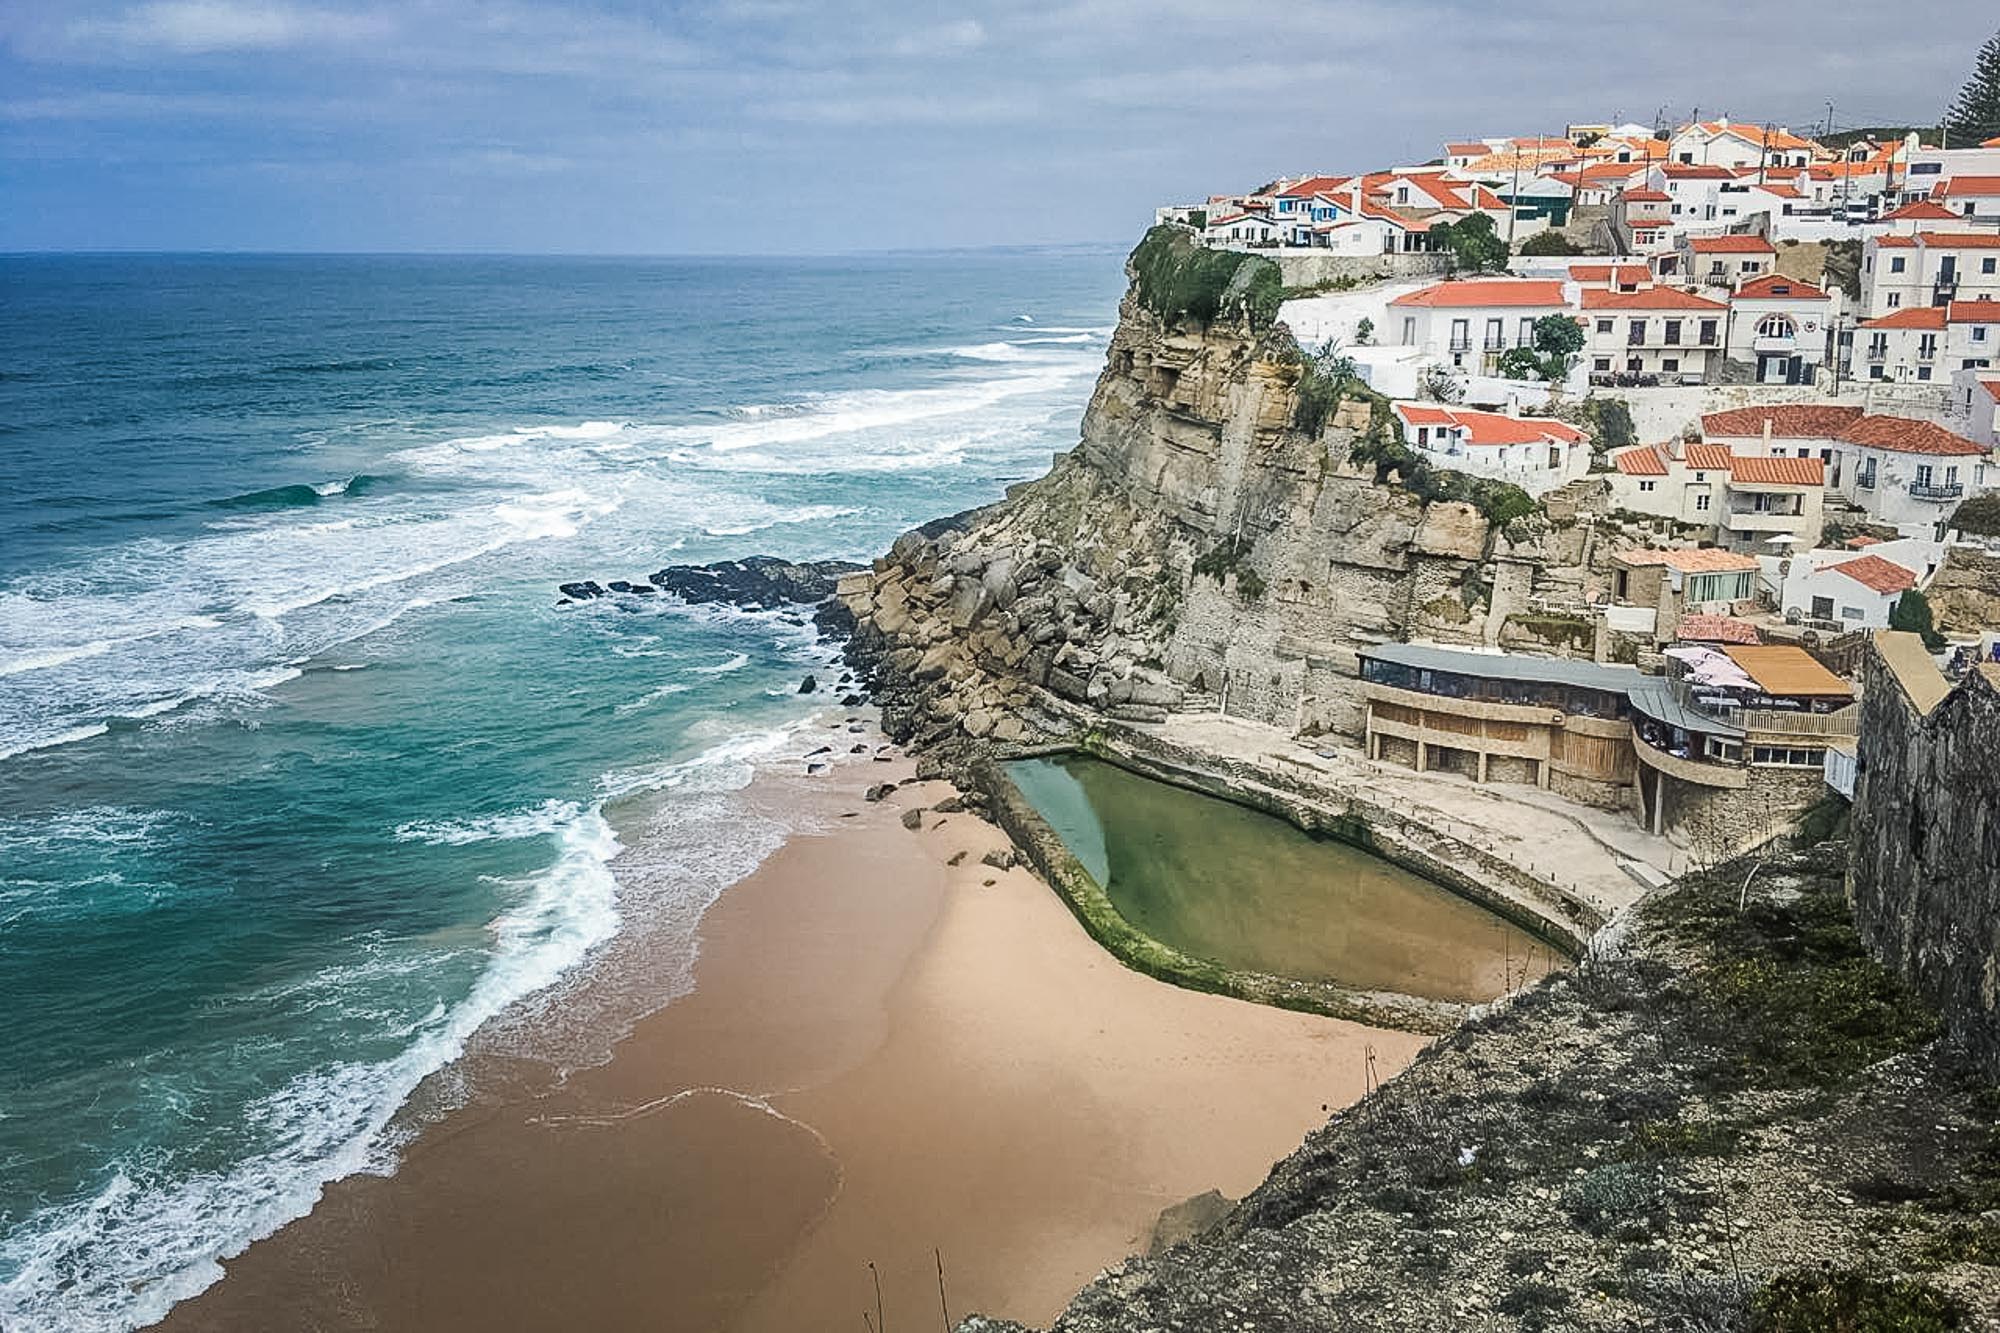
[162,736,1422,1331]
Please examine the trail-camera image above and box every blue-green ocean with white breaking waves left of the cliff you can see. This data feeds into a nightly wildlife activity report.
[0,250,1122,1333]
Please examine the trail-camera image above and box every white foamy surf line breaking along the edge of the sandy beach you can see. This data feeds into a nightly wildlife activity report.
[0,715,836,1333]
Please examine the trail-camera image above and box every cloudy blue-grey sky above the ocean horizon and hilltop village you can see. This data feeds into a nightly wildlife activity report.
[0,0,2000,254]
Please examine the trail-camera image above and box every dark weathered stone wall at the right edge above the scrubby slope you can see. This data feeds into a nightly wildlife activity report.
[1848,652,2000,1077]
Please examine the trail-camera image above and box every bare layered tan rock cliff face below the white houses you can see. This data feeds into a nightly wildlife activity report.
[842,278,1582,743]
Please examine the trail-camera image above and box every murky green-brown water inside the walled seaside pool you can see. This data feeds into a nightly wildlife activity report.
[1008,755,1562,1003]
